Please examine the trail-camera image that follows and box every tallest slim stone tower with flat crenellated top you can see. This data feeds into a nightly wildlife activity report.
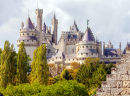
[36,9,43,46]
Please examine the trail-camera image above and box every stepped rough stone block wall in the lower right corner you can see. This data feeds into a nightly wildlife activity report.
[95,54,130,96]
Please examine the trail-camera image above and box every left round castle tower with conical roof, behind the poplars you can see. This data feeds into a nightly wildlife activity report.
[17,17,38,61]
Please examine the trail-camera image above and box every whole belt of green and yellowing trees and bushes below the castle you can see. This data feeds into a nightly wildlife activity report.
[0,41,114,96]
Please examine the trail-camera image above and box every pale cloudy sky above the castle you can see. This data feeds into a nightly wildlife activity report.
[0,0,130,51]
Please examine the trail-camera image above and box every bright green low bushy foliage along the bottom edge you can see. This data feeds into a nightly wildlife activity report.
[0,80,89,96]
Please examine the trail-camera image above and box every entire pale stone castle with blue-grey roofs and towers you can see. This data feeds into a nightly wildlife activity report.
[17,8,122,66]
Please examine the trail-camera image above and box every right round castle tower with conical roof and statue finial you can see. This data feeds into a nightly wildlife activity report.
[77,28,98,63]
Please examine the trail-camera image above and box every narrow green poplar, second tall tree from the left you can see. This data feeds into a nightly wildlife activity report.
[17,42,28,84]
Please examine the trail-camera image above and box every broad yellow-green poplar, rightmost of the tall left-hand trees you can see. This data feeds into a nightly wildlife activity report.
[31,45,49,85]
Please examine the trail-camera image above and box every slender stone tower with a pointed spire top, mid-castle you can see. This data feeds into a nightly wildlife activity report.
[51,14,58,44]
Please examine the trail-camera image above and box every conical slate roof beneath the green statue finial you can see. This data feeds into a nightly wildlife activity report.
[82,28,95,41]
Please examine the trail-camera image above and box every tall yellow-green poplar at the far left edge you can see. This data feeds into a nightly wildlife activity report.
[0,41,16,88]
